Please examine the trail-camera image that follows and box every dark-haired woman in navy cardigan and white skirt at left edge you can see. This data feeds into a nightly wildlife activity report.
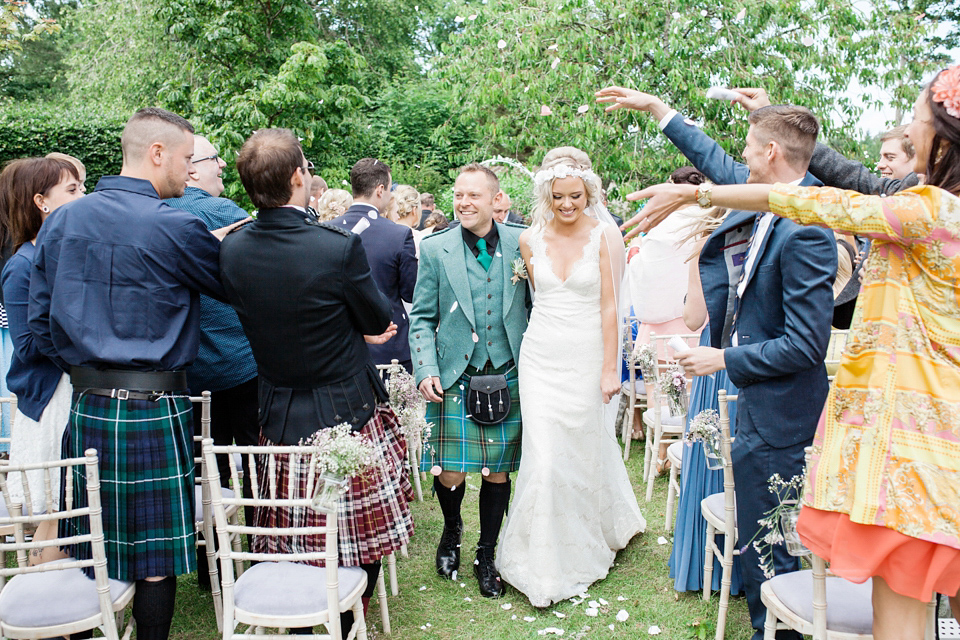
[0,158,83,564]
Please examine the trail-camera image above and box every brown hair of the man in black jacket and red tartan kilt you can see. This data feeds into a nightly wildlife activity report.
[237,129,304,209]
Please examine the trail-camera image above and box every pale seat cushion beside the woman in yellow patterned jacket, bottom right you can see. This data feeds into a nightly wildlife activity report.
[768,570,873,635]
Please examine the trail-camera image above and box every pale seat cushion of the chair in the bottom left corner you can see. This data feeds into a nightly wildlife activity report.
[0,558,134,627]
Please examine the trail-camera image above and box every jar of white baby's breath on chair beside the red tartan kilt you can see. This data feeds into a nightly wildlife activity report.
[300,423,377,510]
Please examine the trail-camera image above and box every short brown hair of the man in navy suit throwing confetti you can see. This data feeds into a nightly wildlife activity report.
[747,104,820,171]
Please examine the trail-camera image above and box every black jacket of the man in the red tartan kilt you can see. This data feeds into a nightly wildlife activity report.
[220,207,395,444]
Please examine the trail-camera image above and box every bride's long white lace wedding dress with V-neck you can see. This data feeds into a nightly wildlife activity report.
[497,225,646,607]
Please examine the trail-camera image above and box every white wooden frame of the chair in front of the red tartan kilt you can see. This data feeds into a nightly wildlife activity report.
[203,439,340,638]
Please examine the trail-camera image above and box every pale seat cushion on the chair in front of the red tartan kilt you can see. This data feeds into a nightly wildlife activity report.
[234,562,367,616]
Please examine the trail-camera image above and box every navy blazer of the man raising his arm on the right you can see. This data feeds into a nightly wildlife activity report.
[664,115,837,448]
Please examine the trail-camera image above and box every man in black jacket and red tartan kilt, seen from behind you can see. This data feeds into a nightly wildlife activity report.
[220,129,413,633]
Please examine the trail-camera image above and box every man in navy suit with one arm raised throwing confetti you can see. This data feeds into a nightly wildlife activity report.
[597,87,837,640]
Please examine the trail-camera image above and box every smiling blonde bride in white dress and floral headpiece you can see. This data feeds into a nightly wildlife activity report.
[497,147,646,607]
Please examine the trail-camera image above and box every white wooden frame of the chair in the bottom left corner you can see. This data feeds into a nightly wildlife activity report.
[0,449,129,639]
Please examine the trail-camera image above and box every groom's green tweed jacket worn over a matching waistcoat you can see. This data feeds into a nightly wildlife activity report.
[410,222,530,389]
